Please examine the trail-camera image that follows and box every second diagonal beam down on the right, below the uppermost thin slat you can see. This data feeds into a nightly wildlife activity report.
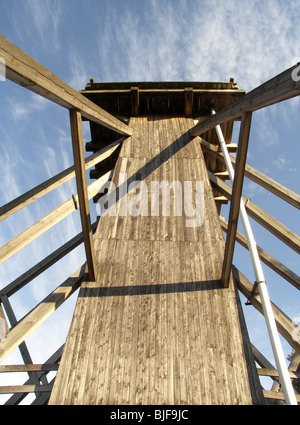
[208,171,300,254]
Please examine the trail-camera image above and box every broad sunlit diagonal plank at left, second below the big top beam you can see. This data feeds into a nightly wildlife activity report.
[0,171,111,264]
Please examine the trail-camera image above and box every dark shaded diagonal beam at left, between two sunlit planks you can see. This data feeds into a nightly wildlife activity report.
[0,222,98,300]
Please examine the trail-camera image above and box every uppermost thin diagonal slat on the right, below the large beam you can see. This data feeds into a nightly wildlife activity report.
[199,138,300,209]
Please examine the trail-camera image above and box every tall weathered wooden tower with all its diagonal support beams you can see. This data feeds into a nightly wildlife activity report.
[0,37,300,405]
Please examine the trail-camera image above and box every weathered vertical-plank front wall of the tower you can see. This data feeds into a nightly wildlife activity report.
[49,115,264,405]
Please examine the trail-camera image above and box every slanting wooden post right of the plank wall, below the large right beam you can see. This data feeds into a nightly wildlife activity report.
[222,112,252,288]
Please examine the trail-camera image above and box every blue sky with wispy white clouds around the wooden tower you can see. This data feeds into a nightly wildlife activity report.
[0,0,300,404]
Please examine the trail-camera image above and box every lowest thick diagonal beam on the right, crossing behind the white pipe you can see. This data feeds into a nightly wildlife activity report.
[232,266,300,353]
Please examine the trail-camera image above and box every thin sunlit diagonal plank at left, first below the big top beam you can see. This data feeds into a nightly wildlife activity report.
[0,137,124,221]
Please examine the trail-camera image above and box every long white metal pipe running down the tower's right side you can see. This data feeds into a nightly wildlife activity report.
[211,109,297,405]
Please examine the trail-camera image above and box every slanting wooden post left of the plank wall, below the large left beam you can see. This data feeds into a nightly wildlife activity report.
[70,109,97,281]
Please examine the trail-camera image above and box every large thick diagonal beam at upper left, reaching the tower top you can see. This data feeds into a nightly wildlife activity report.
[0,35,132,136]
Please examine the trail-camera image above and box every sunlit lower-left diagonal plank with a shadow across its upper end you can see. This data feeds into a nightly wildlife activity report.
[0,264,86,362]
